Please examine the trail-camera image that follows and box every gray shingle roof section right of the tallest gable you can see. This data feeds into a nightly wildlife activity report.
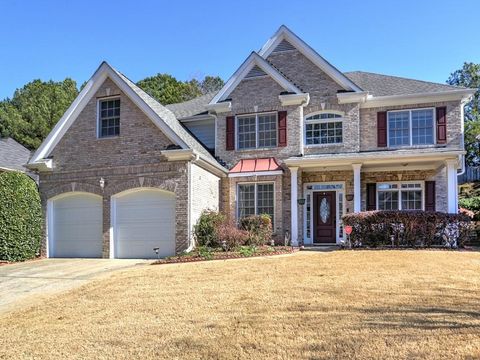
[345,71,460,96]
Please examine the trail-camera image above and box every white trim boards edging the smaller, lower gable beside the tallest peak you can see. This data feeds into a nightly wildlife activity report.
[209,52,302,105]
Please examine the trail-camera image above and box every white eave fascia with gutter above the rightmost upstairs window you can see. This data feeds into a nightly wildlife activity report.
[360,89,476,108]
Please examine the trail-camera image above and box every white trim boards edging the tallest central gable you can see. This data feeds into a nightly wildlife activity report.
[259,25,363,92]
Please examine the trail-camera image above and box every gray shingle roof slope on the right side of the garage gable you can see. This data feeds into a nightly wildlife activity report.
[112,68,221,166]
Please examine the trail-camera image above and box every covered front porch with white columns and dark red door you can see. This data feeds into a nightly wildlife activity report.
[285,149,463,246]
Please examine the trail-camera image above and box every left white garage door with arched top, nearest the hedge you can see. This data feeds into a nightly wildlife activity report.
[49,193,103,258]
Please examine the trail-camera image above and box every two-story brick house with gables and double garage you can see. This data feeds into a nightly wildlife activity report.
[29,26,474,257]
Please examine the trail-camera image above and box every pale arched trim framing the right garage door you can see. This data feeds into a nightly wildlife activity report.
[110,187,176,259]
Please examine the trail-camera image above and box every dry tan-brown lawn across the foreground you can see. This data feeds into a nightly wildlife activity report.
[0,251,480,359]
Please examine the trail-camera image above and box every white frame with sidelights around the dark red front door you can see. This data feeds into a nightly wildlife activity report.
[303,181,346,245]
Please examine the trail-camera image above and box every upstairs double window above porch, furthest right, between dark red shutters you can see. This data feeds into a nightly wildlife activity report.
[387,109,435,146]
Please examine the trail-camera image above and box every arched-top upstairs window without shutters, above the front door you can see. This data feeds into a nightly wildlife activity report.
[305,113,343,145]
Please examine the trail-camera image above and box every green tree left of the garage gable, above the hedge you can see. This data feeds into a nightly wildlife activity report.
[0,78,78,149]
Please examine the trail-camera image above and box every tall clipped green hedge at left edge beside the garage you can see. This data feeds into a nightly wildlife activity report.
[0,172,43,261]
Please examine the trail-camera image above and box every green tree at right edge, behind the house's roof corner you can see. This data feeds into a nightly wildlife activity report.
[447,63,480,166]
